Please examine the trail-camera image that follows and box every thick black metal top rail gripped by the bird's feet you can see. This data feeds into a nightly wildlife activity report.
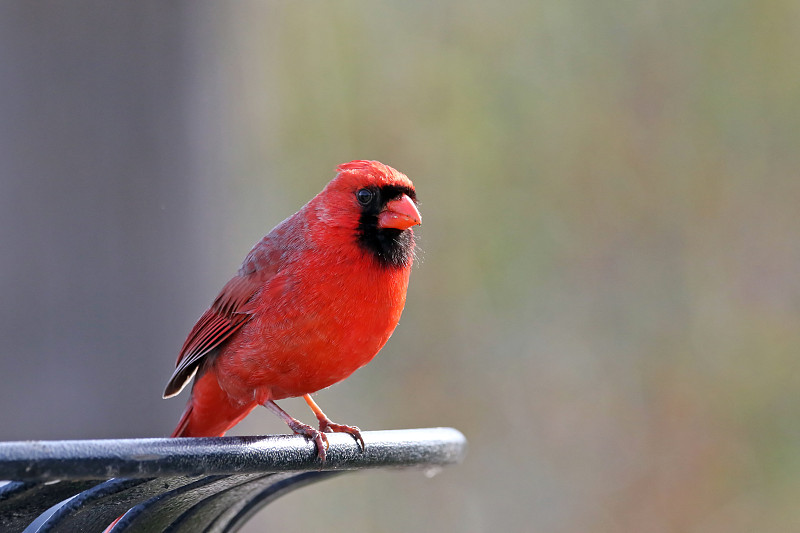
[0,428,466,481]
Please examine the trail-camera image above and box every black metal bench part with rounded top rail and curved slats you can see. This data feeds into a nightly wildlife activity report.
[0,428,466,533]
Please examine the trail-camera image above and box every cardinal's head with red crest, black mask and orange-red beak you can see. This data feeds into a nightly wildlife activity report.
[315,157,422,267]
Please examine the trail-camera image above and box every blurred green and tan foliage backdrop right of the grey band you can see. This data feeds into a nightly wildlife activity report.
[195,0,800,532]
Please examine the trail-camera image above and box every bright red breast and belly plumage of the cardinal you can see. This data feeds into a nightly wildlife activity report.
[216,252,408,400]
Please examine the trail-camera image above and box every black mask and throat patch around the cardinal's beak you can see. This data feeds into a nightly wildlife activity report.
[358,185,416,267]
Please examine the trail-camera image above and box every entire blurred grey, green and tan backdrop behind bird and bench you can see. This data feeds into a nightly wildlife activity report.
[0,0,800,533]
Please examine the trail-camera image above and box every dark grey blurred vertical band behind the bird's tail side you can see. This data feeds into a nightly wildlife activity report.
[0,2,227,440]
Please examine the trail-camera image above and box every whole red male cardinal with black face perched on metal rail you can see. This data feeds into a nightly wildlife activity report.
[164,161,421,461]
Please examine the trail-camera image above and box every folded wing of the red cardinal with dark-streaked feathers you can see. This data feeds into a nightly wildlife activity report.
[164,271,270,398]
